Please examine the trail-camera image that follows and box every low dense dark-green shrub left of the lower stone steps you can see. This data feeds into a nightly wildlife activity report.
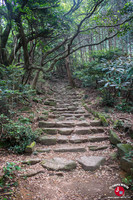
[0,115,37,153]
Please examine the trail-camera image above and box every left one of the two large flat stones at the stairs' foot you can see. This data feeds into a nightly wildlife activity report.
[41,157,77,171]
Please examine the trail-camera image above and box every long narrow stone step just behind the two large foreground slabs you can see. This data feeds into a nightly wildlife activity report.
[53,146,86,152]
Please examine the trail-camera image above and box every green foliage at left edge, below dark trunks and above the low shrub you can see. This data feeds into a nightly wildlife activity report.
[0,65,35,114]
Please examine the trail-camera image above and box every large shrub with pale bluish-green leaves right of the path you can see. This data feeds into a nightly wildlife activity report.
[74,49,133,112]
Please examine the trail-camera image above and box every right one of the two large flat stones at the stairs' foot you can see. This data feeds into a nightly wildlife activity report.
[78,156,105,171]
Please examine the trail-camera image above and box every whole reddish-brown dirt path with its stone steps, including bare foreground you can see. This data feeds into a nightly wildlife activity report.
[1,80,131,200]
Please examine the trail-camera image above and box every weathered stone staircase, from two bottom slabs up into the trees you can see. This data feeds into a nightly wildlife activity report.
[32,85,109,171]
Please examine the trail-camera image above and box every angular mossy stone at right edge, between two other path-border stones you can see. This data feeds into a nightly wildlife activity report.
[117,144,133,157]
